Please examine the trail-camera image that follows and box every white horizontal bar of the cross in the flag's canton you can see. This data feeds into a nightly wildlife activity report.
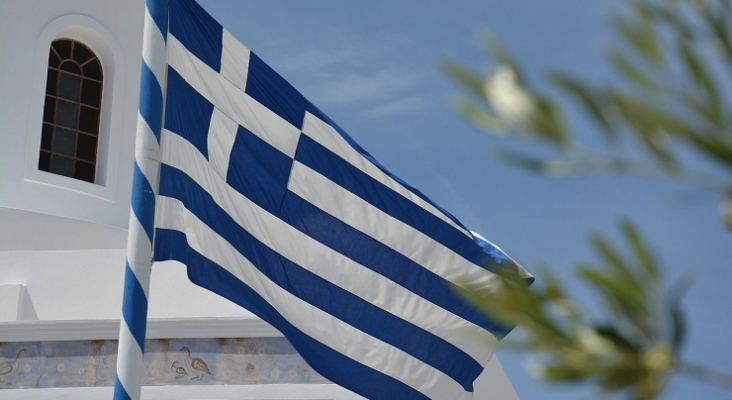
[168,35,300,157]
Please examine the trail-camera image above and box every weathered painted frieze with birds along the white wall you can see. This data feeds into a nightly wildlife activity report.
[0,338,328,388]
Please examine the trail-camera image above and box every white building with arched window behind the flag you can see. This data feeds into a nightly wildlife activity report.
[0,0,517,399]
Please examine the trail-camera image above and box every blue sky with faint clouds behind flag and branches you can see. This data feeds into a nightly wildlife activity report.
[199,0,732,399]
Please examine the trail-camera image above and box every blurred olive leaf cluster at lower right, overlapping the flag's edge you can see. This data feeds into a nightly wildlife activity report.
[467,221,688,399]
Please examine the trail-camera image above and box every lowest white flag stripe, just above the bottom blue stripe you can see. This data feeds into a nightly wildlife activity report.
[159,197,465,399]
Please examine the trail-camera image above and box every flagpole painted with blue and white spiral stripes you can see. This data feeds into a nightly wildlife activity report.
[114,0,168,400]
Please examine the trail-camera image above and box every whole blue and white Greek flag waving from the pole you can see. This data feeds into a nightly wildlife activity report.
[154,0,529,399]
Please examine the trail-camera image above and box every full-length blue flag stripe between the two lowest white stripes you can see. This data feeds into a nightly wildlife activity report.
[156,164,483,391]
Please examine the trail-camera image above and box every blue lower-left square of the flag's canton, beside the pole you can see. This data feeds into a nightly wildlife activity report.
[165,67,214,158]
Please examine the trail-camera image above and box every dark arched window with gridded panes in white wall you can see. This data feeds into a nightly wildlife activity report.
[38,39,103,182]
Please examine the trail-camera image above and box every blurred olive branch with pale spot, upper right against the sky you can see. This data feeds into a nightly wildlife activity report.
[444,0,732,225]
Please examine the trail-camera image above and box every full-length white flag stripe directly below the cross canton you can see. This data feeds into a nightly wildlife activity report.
[158,130,497,363]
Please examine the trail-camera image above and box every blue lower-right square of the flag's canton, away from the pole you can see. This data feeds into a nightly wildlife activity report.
[226,126,292,215]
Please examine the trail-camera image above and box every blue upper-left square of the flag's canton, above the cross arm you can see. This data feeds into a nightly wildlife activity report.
[169,0,224,72]
